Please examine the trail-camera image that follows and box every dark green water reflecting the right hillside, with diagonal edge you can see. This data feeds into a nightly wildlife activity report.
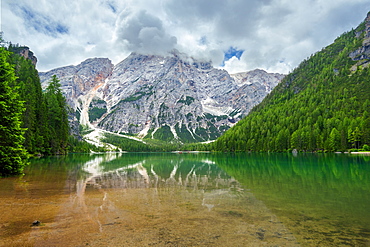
[214,154,370,246]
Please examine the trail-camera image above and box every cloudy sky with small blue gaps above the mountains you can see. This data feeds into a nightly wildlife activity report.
[0,0,370,73]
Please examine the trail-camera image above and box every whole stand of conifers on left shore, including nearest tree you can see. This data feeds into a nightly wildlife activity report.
[0,44,69,176]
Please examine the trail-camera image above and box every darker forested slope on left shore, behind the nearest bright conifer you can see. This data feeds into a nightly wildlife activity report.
[8,45,69,154]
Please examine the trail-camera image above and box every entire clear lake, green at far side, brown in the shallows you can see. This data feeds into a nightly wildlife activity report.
[0,153,370,247]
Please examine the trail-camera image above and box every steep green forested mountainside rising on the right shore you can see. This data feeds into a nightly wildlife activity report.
[209,12,370,152]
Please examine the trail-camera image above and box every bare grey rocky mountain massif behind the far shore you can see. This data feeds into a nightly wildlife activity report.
[40,51,284,142]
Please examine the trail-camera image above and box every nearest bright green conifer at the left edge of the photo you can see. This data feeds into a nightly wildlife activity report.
[0,48,27,177]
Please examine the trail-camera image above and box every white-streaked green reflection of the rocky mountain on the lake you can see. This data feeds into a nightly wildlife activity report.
[78,154,237,192]
